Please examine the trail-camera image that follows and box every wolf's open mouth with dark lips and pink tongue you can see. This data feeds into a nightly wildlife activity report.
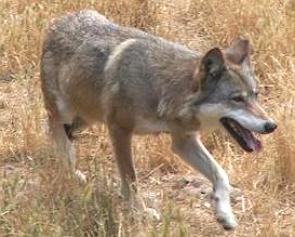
[220,118,262,152]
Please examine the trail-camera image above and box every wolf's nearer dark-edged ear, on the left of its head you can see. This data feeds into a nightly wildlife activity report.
[201,48,225,78]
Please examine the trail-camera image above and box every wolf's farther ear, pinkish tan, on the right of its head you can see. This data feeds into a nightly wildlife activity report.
[223,38,250,65]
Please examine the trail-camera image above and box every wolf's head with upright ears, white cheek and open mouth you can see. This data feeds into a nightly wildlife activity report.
[194,39,277,152]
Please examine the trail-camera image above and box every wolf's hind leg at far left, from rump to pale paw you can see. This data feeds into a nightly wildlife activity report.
[40,51,86,181]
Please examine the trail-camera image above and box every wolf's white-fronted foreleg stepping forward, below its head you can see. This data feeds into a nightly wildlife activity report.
[172,133,237,230]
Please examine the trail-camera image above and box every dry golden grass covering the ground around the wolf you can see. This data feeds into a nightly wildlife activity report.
[0,0,295,236]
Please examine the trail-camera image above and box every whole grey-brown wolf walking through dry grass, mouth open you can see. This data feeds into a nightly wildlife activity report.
[40,10,277,230]
